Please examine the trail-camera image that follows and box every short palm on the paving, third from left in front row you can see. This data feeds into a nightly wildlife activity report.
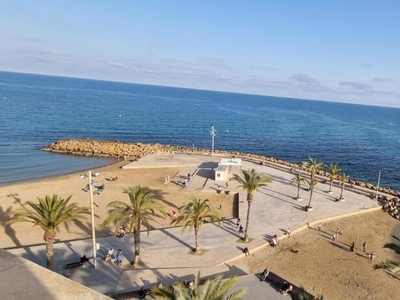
[171,197,221,253]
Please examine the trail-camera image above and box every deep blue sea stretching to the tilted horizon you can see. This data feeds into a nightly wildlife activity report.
[0,72,400,190]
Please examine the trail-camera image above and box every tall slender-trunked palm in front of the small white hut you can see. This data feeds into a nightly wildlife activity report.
[229,169,272,242]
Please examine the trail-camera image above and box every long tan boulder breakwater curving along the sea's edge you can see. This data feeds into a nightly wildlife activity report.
[42,139,399,196]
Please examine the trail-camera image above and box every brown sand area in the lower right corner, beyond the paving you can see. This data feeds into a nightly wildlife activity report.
[235,211,400,299]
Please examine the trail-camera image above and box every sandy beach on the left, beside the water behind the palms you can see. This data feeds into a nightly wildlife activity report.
[0,160,233,248]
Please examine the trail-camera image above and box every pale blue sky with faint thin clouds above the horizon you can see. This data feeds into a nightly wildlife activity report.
[0,0,400,107]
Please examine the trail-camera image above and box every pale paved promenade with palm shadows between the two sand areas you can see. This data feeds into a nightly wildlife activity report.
[10,154,378,299]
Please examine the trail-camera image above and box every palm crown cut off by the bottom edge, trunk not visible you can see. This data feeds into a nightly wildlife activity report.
[151,273,246,300]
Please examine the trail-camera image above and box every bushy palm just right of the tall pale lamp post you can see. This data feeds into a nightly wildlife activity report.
[101,186,165,266]
